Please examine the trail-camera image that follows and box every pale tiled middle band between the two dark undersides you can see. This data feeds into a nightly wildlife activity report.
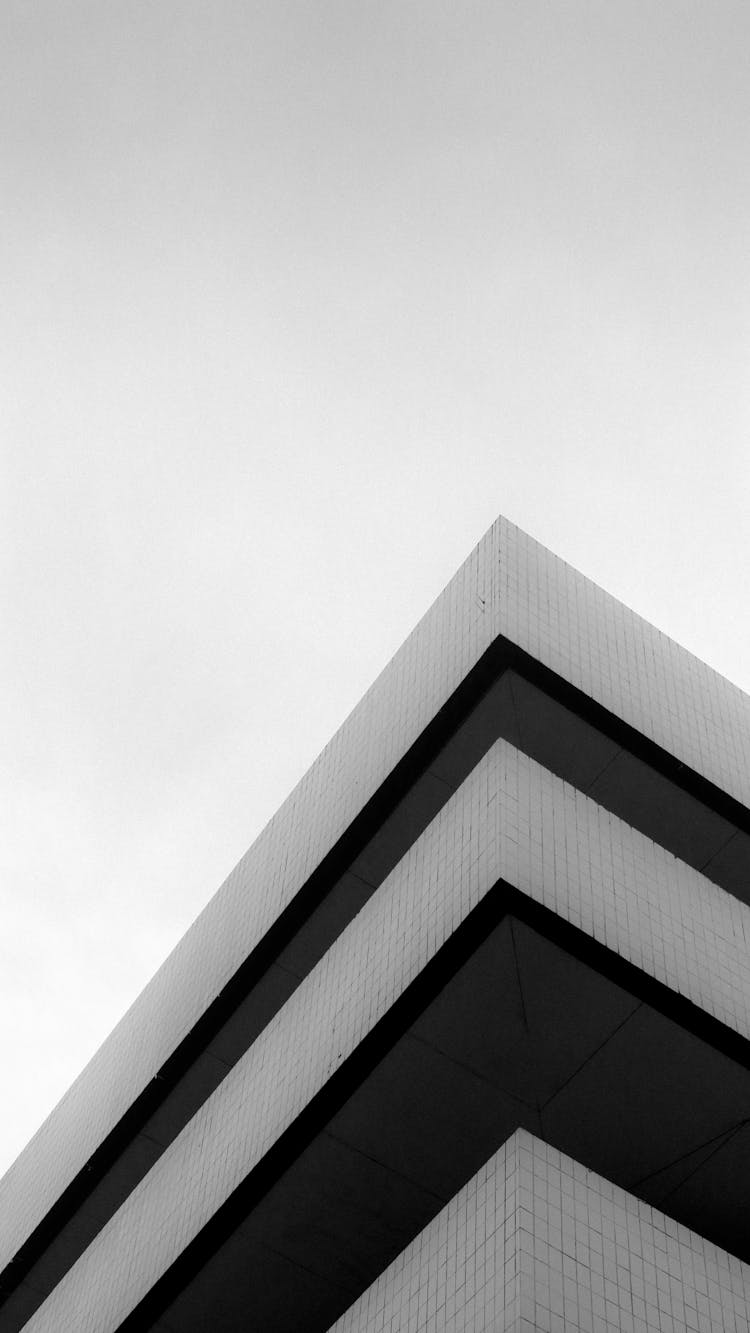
[20,741,750,1333]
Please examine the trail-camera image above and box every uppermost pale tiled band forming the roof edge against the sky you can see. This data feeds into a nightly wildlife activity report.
[0,519,750,1317]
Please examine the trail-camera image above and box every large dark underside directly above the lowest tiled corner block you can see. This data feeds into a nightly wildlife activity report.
[119,884,750,1333]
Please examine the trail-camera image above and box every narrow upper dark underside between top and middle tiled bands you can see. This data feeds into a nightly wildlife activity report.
[0,639,750,1333]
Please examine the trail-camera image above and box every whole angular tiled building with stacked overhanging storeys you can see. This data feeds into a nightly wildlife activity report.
[0,519,750,1333]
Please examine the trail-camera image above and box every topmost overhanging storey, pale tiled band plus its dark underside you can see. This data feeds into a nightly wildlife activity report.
[0,520,750,1333]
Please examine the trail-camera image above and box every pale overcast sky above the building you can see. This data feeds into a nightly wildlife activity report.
[0,0,750,1170]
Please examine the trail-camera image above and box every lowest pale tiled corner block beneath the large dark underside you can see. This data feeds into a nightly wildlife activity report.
[330,1129,750,1333]
